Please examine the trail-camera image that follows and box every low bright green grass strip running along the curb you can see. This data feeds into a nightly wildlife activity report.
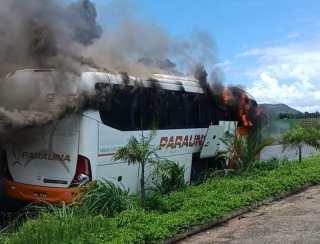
[2,157,320,243]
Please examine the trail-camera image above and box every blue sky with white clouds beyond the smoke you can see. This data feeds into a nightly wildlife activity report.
[94,0,320,112]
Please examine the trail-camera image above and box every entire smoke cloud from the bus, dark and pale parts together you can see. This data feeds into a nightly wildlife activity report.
[0,0,258,139]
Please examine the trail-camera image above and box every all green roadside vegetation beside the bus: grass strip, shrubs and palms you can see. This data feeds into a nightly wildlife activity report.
[0,127,320,244]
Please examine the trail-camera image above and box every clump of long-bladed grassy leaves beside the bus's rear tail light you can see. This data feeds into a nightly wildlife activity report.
[77,180,131,217]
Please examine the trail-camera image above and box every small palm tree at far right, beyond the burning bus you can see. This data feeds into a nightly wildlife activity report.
[281,127,320,162]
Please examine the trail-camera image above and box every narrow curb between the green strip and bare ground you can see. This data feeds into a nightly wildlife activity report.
[163,183,317,244]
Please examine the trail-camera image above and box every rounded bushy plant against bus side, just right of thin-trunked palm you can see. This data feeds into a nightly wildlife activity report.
[153,160,186,194]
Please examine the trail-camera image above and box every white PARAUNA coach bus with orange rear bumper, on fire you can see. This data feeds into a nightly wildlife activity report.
[1,70,252,203]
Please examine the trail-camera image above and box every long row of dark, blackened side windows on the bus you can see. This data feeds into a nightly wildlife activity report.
[98,82,224,131]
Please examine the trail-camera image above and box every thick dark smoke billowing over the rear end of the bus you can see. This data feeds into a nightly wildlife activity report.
[0,0,102,137]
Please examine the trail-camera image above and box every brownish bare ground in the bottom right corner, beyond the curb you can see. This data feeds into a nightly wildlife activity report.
[179,186,320,244]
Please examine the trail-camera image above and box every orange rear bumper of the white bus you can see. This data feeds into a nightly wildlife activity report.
[4,179,79,203]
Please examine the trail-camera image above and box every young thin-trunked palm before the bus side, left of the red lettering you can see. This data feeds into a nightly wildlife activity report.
[113,132,159,207]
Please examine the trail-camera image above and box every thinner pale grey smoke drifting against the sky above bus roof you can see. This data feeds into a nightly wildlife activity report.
[83,5,216,78]
